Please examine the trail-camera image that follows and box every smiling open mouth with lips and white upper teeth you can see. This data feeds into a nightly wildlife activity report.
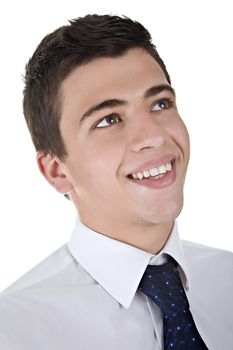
[127,159,176,189]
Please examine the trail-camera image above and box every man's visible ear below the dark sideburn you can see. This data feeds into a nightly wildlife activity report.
[36,152,73,194]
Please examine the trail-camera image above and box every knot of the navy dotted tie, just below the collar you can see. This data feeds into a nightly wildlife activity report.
[139,257,189,315]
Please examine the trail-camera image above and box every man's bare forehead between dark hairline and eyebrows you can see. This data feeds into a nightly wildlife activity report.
[61,48,167,121]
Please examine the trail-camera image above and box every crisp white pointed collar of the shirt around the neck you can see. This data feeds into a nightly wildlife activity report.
[68,219,188,308]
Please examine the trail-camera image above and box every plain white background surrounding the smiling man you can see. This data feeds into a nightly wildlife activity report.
[0,0,233,290]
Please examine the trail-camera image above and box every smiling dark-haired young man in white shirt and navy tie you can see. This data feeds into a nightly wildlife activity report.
[0,15,233,350]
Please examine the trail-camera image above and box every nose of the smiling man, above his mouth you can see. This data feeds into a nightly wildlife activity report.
[130,113,167,152]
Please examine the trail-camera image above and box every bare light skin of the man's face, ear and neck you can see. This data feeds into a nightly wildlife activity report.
[37,48,189,254]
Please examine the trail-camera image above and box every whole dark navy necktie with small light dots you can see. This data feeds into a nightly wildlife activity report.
[139,258,208,350]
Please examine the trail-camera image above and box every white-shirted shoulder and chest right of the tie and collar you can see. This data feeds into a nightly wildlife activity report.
[182,241,233,349]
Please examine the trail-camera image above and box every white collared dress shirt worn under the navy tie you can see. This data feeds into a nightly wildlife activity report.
[0,220,233,350]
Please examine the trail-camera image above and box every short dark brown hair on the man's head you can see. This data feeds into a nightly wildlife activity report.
[23,14,170,161]
